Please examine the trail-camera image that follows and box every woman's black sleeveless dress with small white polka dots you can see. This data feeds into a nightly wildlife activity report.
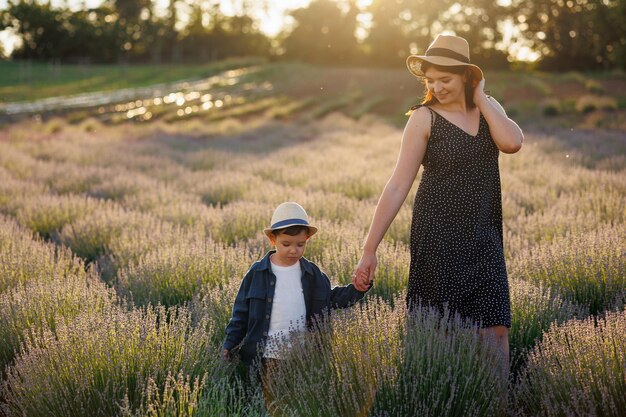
[407,110,511,327]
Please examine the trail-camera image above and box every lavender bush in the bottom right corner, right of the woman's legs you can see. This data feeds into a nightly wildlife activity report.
[513,311,626,417]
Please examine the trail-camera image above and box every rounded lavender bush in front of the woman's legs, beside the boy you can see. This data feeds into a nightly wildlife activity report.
[265,301,507,416]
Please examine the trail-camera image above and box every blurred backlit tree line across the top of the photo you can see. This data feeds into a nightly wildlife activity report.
[0,0,626,70]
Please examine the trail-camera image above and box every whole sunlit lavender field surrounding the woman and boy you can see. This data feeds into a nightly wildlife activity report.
[0,64,626,417]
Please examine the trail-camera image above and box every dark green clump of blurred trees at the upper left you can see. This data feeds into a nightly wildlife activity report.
[3,0,270,63]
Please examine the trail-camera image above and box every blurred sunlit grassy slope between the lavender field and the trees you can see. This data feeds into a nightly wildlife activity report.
[0,59,625,132]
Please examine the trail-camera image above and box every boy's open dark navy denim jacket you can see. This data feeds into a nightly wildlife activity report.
[224,250,365,365]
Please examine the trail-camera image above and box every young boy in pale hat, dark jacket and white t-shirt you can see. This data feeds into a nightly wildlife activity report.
[223,202,365,365]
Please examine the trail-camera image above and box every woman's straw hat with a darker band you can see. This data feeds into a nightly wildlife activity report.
[406,35,483,81]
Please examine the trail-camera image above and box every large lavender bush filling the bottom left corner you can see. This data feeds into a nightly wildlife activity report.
[3,307,221,417]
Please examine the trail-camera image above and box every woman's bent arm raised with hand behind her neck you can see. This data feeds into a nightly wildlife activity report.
[474,79,524,153]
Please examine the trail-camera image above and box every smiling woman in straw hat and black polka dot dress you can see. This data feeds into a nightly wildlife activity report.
[353,35,523,358]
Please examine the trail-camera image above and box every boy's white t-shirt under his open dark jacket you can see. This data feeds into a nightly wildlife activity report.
[263,262,306,359]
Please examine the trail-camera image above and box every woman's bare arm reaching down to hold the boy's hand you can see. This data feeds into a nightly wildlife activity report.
[353,107,432,291]
